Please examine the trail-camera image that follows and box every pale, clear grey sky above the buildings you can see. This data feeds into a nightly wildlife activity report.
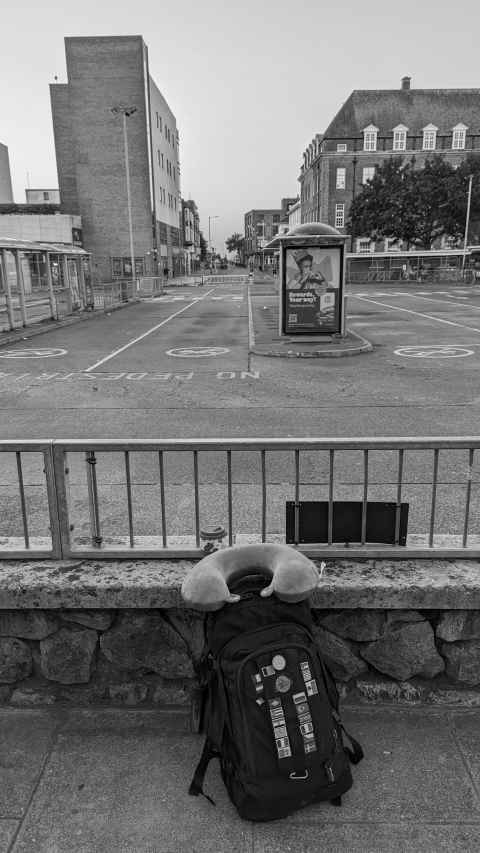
[0,0,480,250]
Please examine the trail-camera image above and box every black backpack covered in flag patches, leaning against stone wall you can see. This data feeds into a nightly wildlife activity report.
[189,576,363,821]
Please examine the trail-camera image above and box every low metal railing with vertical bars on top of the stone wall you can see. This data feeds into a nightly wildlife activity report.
[0,437,480,559]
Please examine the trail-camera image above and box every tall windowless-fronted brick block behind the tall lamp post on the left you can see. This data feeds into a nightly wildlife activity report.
[50,36,183,281]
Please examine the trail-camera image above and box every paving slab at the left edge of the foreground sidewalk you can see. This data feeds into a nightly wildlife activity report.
[0,709,59,816]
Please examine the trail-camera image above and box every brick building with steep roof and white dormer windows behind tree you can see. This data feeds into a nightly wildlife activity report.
[299,77,480,251]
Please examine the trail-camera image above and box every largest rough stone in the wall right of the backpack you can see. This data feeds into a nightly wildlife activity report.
[360,621,444,681]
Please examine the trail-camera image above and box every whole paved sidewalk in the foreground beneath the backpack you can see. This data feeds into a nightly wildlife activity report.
[0,705,480,853]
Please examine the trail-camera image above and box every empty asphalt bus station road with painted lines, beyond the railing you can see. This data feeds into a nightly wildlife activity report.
[0,276,480,535]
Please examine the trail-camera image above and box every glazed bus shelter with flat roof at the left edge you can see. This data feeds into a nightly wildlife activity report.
[0,238,93,331]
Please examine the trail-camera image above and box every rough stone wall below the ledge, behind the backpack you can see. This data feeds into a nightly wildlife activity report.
[0,608,480,706]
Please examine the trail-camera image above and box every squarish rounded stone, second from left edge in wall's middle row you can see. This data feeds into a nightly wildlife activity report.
[40,626,98,684]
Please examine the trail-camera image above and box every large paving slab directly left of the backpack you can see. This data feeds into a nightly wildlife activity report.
[12,712,252,853]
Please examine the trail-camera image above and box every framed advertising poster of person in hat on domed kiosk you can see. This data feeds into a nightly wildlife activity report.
[283,247,341,335]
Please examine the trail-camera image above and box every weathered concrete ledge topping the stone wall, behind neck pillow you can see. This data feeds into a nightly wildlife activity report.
[0,559,480,610]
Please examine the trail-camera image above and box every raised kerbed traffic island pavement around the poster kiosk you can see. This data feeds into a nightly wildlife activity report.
[248,276,373,358]
